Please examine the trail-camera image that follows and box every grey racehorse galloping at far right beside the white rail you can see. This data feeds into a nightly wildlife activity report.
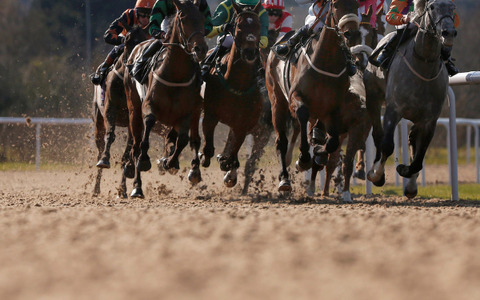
[365,0,457,198]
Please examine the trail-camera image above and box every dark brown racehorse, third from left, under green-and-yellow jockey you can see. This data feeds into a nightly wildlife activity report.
[202,1,262,187]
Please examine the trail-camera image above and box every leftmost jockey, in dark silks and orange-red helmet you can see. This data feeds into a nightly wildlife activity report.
[90,0,154,85]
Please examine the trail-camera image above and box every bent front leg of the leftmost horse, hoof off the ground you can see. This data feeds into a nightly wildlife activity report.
[97,91,117,169]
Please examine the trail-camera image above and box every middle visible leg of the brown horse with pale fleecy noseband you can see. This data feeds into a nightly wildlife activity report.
[291,92,312,171]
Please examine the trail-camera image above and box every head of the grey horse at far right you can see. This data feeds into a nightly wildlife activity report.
[415,0,457,47]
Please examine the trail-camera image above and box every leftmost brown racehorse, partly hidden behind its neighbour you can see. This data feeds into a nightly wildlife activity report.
[93,26,147,198]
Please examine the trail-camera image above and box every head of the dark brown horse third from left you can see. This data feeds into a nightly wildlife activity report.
[232,1,262,63]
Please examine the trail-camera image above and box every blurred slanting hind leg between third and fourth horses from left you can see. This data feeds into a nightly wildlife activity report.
[242,122,272,195]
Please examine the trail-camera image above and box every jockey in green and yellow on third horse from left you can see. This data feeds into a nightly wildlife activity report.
[202,0,269,76]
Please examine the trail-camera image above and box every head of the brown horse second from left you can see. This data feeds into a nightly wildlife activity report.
[170,0,208,62]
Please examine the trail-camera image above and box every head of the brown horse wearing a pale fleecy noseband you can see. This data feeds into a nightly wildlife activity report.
[327,0,361,46]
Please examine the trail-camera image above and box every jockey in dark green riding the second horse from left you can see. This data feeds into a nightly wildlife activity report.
[131,0,213,82]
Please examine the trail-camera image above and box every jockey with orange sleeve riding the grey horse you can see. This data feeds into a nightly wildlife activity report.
[371,0,460,76]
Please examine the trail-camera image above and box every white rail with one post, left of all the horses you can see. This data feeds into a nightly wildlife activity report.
[0,117,92,170]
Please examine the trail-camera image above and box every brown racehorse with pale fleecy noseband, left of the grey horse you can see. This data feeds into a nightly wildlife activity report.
[266,0,359,192]
